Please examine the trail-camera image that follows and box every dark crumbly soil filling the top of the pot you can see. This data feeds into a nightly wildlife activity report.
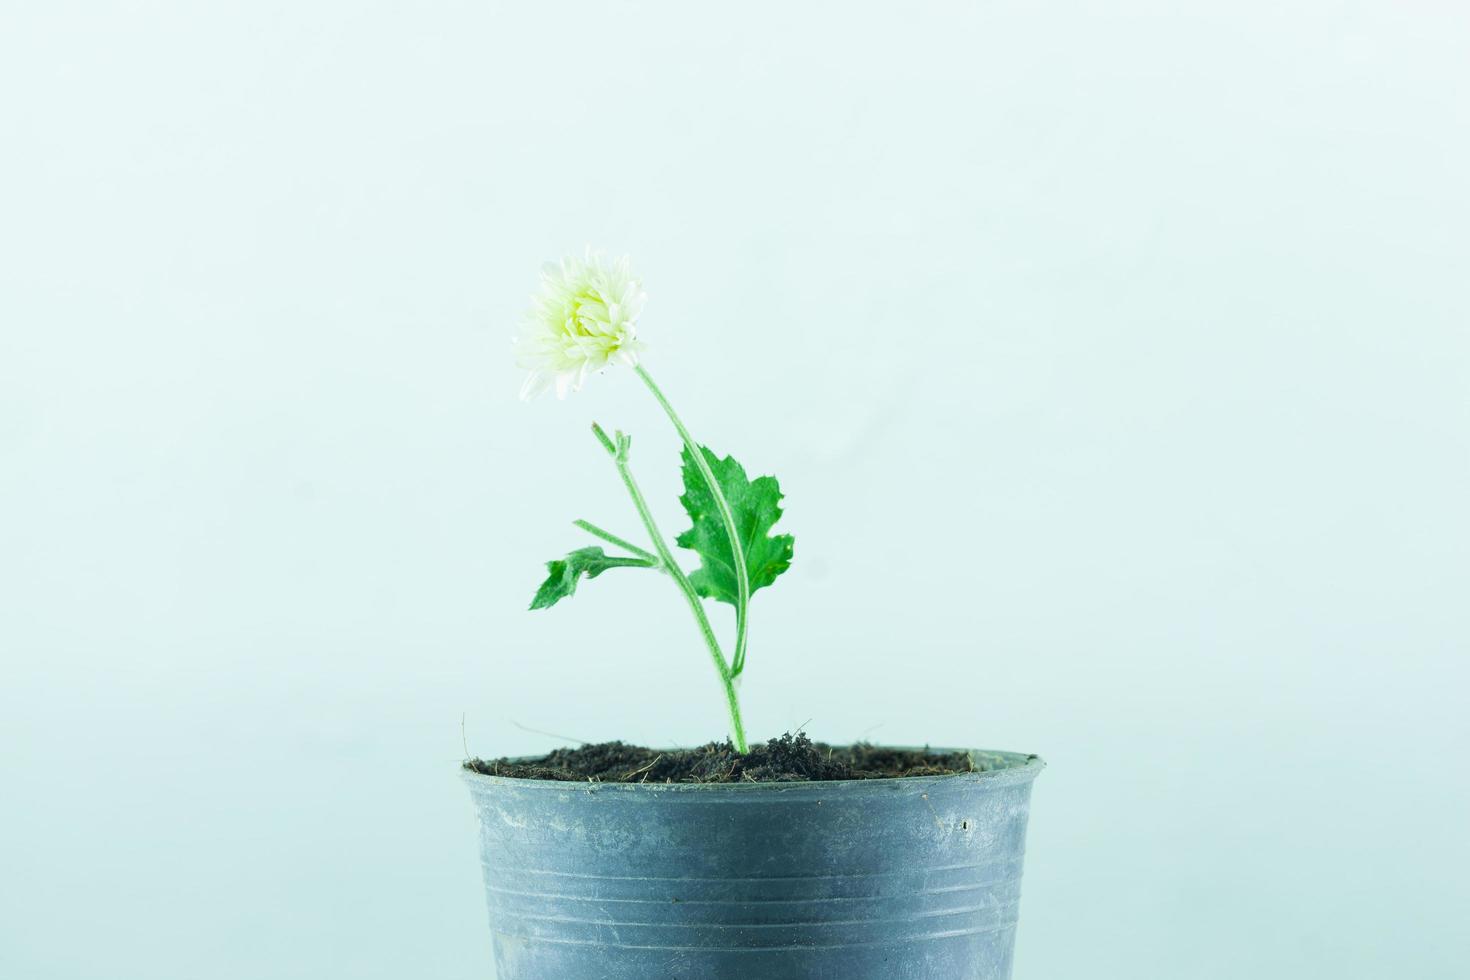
[465,735,1017,783]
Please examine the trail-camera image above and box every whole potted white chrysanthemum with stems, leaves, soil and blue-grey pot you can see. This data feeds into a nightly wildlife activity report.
[463,253,1042,980]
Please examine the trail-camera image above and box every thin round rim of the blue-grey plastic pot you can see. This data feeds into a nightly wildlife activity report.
[460,745,1047,793]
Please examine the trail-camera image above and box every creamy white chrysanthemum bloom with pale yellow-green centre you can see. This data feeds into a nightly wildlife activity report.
[516,251,645,401]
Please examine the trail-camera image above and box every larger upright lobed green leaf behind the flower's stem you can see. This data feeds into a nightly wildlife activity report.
[675,447,795,605]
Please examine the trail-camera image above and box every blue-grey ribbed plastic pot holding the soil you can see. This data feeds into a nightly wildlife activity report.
[465,752,1042,980]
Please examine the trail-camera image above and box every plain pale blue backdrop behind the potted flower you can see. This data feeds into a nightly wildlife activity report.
[0,0,1470,980]
